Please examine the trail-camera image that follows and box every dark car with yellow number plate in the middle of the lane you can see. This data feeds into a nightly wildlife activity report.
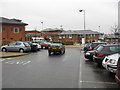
[48,43,65,55]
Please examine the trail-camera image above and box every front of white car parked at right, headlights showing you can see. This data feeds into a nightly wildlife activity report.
[102,53,120,73]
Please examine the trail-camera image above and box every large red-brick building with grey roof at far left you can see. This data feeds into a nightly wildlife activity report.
[0,17,28,40]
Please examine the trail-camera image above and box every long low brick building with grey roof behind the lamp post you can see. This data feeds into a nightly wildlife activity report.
[58,30,103,43]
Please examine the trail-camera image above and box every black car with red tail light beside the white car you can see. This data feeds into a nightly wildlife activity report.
[93,44,120,65]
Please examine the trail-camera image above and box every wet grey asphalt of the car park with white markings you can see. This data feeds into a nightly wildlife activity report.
[2,48,117,88]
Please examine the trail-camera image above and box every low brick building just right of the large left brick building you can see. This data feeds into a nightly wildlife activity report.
[25,30,45,41]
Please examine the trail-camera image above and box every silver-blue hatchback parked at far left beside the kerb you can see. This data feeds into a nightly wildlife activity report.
[1,42,31,53]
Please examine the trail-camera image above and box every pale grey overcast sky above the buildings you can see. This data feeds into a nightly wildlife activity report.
[0,0,119,33]
